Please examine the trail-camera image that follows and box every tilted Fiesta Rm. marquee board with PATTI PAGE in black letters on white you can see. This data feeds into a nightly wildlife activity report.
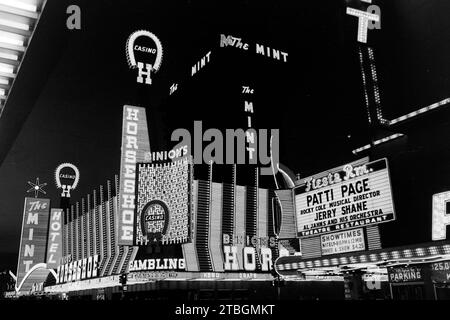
[294,159,395,237]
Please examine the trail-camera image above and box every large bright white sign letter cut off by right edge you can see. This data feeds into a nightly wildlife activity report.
[432,191,450,241]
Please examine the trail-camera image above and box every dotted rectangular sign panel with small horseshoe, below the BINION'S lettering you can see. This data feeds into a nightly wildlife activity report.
[135,157,192,245]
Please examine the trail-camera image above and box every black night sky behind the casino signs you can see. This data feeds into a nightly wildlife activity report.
[0,0,450,270]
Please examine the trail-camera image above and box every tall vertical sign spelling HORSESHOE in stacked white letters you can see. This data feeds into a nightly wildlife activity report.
[118,106,150,245]
